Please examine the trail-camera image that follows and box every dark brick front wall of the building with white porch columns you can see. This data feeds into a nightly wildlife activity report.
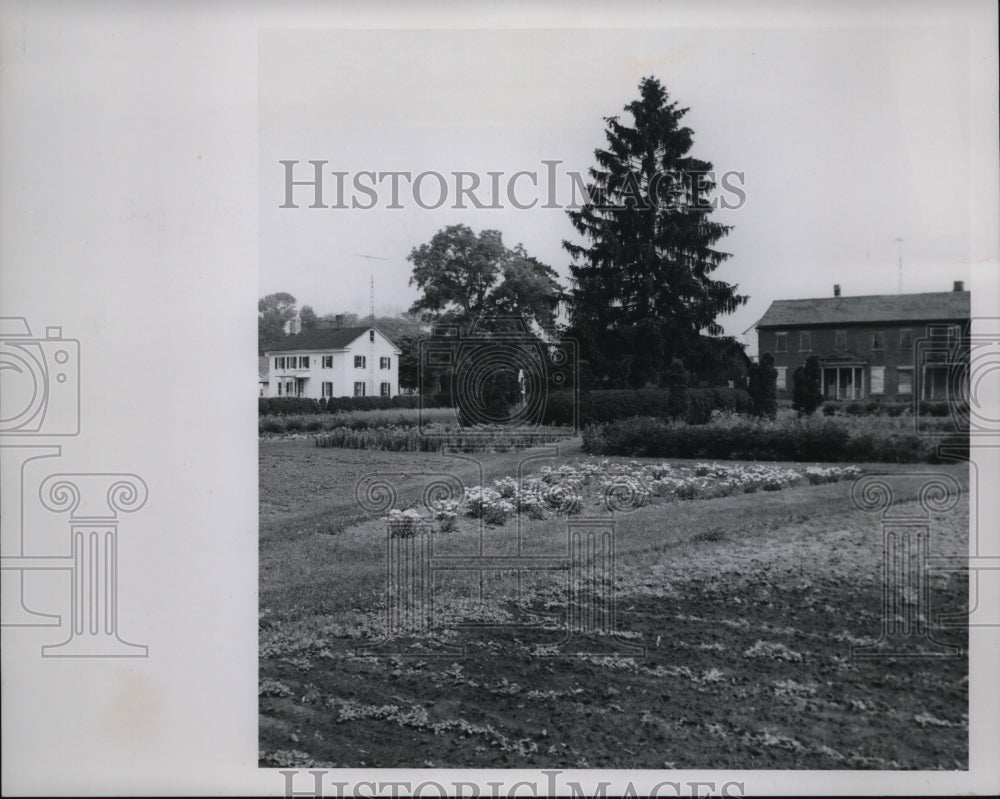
[757,320,967,401]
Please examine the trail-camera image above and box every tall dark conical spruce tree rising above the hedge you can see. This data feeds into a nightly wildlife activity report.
[563,77,747,386]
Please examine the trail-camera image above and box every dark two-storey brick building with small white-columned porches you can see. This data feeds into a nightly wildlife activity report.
[755,281,970,401]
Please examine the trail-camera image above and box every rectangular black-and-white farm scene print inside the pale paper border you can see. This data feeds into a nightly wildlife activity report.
[257,24,984,772]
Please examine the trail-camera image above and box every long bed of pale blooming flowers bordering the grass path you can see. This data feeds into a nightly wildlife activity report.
[385,459,861,535]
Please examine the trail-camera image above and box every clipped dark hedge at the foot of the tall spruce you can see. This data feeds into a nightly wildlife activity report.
[542,388,751,426]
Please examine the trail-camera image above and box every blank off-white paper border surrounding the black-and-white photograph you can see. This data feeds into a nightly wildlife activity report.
[0,0,1000,795]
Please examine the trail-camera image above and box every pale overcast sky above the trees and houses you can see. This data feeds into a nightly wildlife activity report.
[258,20,995,352]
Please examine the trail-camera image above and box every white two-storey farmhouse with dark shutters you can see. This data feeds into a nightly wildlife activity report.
[266,327,400,399]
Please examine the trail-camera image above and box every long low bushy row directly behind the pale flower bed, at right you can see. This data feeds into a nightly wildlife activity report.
[583,418,969,463]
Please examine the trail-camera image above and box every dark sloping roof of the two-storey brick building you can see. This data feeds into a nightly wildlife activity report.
[755,291,971,327]
